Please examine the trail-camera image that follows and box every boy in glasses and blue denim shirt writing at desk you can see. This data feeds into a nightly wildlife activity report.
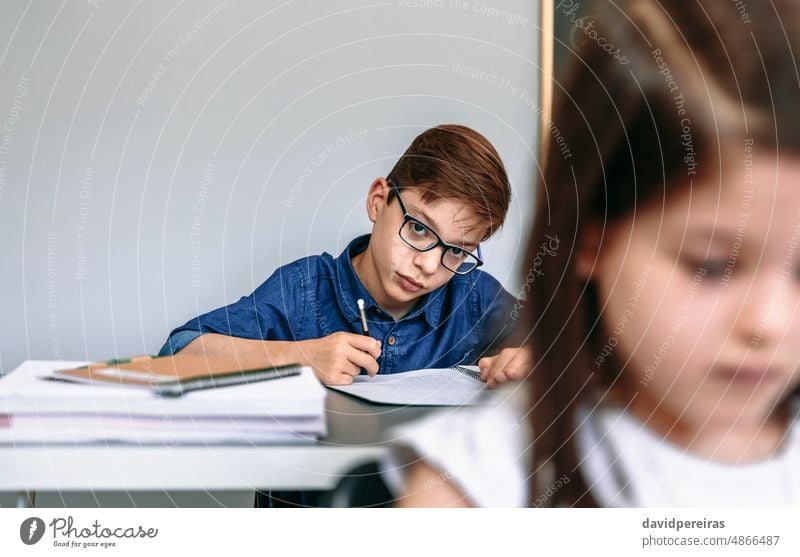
[161,125,531,387]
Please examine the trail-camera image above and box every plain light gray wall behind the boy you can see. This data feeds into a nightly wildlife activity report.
[0,0,539,372]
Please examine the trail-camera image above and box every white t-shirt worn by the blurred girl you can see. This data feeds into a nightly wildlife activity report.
[382,386,800,507]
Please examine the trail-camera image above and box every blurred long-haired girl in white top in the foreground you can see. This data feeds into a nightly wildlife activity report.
[385,0,800,506]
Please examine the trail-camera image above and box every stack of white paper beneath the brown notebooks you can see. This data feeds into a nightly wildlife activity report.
[0,361,326,445]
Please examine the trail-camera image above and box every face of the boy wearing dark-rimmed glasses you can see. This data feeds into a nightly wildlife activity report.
[353,178,488,315]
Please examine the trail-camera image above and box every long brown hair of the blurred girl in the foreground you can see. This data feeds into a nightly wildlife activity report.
[522,0,800,506]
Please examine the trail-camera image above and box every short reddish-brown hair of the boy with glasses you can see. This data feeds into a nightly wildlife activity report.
[388,124,511,239]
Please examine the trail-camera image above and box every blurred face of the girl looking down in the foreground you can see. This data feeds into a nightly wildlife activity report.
[579,152,800,431]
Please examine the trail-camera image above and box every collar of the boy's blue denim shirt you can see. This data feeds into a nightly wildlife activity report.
[335,234,446,328]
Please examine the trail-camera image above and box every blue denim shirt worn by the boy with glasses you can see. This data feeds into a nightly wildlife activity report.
[160,235,515,374]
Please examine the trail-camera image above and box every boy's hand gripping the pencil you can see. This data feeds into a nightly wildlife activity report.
[297,332,381,385]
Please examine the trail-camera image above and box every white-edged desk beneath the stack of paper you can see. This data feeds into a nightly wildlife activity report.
[0,370,430,506]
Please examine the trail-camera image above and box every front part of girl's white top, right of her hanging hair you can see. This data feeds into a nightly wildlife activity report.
[578,401,800,507]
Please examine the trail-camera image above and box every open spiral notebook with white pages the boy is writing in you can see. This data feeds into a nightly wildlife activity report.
[328,365,488,406]
